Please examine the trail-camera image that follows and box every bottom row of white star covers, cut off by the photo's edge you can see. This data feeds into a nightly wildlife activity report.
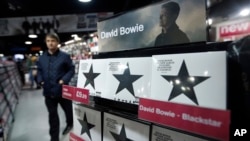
[70,104,207,141]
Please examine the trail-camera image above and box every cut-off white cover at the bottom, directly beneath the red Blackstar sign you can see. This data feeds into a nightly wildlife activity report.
[151,125,209,141]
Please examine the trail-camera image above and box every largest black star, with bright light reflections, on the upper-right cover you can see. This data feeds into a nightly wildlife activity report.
[162,61,209,105]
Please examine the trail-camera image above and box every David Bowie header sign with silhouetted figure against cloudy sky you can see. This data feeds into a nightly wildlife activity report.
[97,0,206,52]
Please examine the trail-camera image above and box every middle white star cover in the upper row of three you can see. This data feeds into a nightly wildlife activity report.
[101,57,151,105]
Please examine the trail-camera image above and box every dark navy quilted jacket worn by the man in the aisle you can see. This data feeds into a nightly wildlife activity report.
[37,49,75,97]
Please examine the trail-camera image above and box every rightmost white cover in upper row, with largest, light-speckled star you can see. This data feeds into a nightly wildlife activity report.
[149,51,227,110]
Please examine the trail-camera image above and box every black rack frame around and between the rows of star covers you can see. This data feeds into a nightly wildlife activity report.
[76,42,249,141]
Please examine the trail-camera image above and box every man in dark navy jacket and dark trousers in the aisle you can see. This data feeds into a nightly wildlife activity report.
[37,33,75,141]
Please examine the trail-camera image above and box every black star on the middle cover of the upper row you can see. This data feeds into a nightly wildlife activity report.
[113,64,142,96]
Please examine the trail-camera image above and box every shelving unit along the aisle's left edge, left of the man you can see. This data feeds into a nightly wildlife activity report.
[0,62,21,137]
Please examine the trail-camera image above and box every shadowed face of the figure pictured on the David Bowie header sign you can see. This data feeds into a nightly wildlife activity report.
[160,8,173,28]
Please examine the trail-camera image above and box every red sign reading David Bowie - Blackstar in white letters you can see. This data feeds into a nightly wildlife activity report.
[138,98,230,140]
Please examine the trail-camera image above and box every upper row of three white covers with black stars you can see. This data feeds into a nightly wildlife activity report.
[77,51,227,109]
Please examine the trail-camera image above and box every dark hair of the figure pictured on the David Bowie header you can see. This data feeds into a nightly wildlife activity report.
[162,1,180,19]
